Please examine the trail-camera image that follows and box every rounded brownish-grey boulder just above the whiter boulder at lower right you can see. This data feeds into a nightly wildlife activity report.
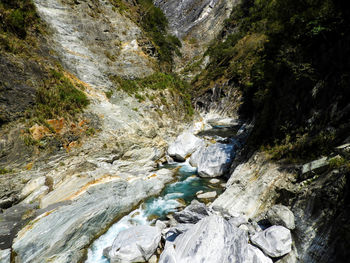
[266,205,295,230]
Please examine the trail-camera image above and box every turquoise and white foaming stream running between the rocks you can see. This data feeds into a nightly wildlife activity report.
[86,163,223,263]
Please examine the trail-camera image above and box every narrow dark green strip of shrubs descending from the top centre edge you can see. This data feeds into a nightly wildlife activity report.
[137,0,181,71]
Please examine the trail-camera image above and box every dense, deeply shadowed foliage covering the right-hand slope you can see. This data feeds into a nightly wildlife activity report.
[194,0,350,161]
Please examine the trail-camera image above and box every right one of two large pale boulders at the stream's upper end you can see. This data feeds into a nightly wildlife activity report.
[190,143,235,177]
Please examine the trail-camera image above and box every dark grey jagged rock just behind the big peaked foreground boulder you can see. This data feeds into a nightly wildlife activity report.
[173,200,209,224]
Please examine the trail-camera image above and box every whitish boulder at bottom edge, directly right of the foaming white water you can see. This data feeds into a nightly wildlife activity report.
[106,225,161,263]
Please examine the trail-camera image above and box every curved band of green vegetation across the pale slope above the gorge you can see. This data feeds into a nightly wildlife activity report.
[113,72,194,116]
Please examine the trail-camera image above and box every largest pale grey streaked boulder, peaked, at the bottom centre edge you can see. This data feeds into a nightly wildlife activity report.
[159,215,248,263]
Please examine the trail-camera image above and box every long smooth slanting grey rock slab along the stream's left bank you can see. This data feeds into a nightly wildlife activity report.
[13,172,172,263]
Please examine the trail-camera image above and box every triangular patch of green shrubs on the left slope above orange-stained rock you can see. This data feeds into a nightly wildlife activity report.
[28,70,89,124]
